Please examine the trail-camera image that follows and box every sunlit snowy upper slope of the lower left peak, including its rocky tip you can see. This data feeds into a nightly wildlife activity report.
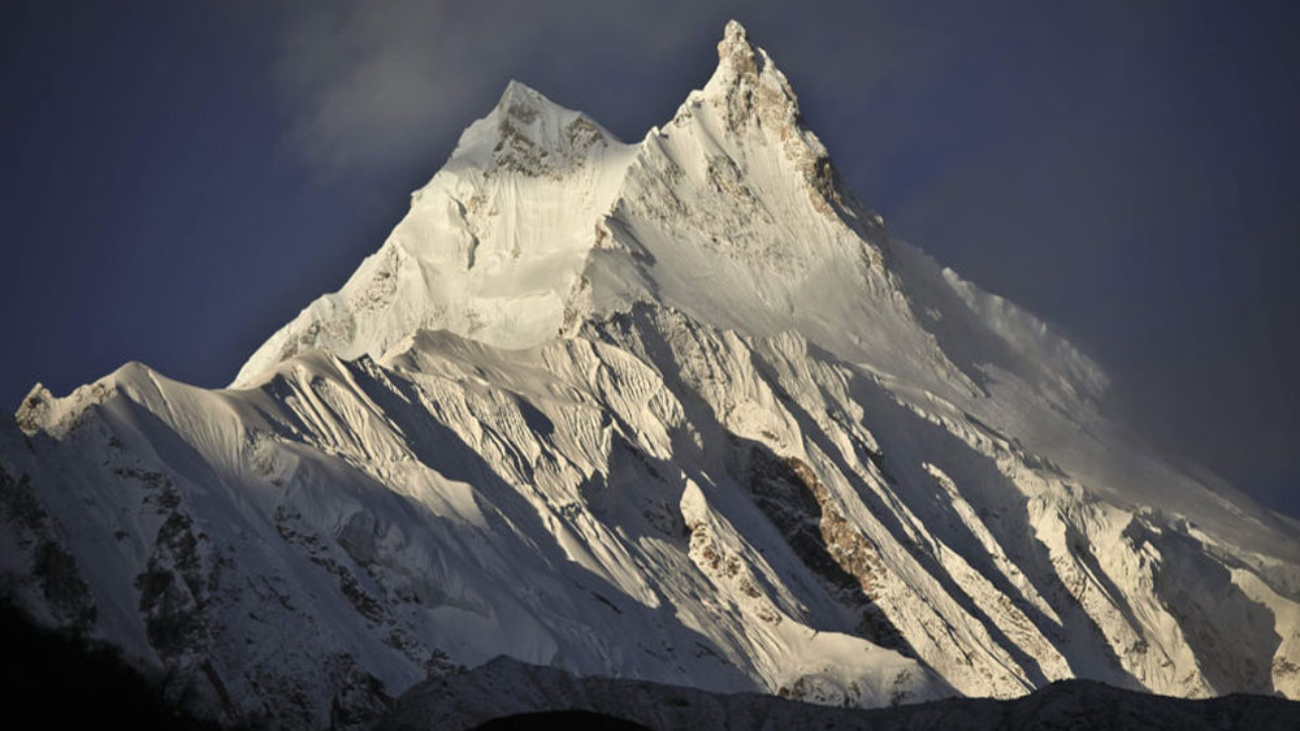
[233,82,636,388]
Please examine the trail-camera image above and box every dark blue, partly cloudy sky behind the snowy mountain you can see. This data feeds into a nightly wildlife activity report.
[0,0,1300,515]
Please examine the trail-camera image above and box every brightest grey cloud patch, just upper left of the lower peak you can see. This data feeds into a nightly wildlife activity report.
[276,0,520,174]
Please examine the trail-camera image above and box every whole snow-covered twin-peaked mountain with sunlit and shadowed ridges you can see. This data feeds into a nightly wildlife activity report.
[0,22,1300,728]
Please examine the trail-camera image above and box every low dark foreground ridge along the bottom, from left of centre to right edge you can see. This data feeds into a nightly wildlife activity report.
[381,658,1300,731]
